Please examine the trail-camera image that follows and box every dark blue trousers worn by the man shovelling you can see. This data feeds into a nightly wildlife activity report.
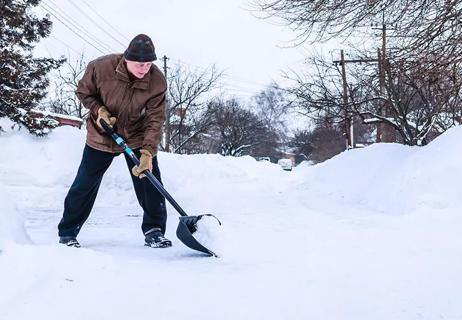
[58,145,167,237]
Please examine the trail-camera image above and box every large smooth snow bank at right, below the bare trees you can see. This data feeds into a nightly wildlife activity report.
[297,127,462,214]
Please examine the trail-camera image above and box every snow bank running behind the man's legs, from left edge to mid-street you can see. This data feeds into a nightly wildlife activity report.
[0,120,284,201]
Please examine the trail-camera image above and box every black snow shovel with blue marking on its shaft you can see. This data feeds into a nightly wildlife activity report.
[100,119,221,257]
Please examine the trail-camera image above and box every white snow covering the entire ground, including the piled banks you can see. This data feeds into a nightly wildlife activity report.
[0,119,462,320]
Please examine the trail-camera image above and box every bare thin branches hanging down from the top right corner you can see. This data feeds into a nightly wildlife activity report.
[254,0,462,72]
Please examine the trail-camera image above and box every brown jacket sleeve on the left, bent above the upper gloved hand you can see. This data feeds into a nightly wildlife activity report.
[76,62,103,121]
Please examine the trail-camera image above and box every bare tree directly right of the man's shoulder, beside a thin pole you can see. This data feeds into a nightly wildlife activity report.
[164,64,222,153]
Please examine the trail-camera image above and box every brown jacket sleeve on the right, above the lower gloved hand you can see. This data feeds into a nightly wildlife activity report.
[143,83,167,156]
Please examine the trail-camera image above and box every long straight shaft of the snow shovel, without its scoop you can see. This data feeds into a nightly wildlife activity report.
[100,119,188,217]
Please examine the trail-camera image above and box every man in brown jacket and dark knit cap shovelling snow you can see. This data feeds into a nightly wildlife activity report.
[58,34,172,248]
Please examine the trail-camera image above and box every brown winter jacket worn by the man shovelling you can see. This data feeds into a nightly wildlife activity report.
[76,54,167,155]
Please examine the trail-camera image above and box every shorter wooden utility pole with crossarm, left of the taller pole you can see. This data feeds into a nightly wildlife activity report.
[334,49,377,150]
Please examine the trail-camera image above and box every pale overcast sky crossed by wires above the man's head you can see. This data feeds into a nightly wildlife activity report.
[37,0,316,97]
